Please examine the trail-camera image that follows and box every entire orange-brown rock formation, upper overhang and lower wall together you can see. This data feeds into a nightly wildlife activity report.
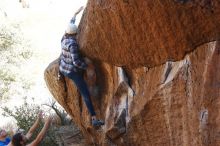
[45,0,220,146]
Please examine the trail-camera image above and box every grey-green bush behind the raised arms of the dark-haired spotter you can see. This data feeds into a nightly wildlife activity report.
[2,100,57,146]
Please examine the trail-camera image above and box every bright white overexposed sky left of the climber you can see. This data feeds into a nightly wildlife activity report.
[0,0,87,127]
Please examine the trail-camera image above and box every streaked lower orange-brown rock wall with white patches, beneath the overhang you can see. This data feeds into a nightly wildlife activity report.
[45,42,220,146]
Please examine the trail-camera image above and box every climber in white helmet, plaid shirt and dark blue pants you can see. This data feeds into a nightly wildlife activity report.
[58,7,104,127]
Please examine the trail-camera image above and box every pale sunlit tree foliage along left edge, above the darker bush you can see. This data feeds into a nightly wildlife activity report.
[0,21,33,100]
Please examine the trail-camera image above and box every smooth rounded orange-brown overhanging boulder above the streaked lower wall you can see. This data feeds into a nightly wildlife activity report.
[79,0,220,67]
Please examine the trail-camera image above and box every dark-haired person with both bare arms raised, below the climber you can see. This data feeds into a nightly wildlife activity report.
[8,112,52,146]
